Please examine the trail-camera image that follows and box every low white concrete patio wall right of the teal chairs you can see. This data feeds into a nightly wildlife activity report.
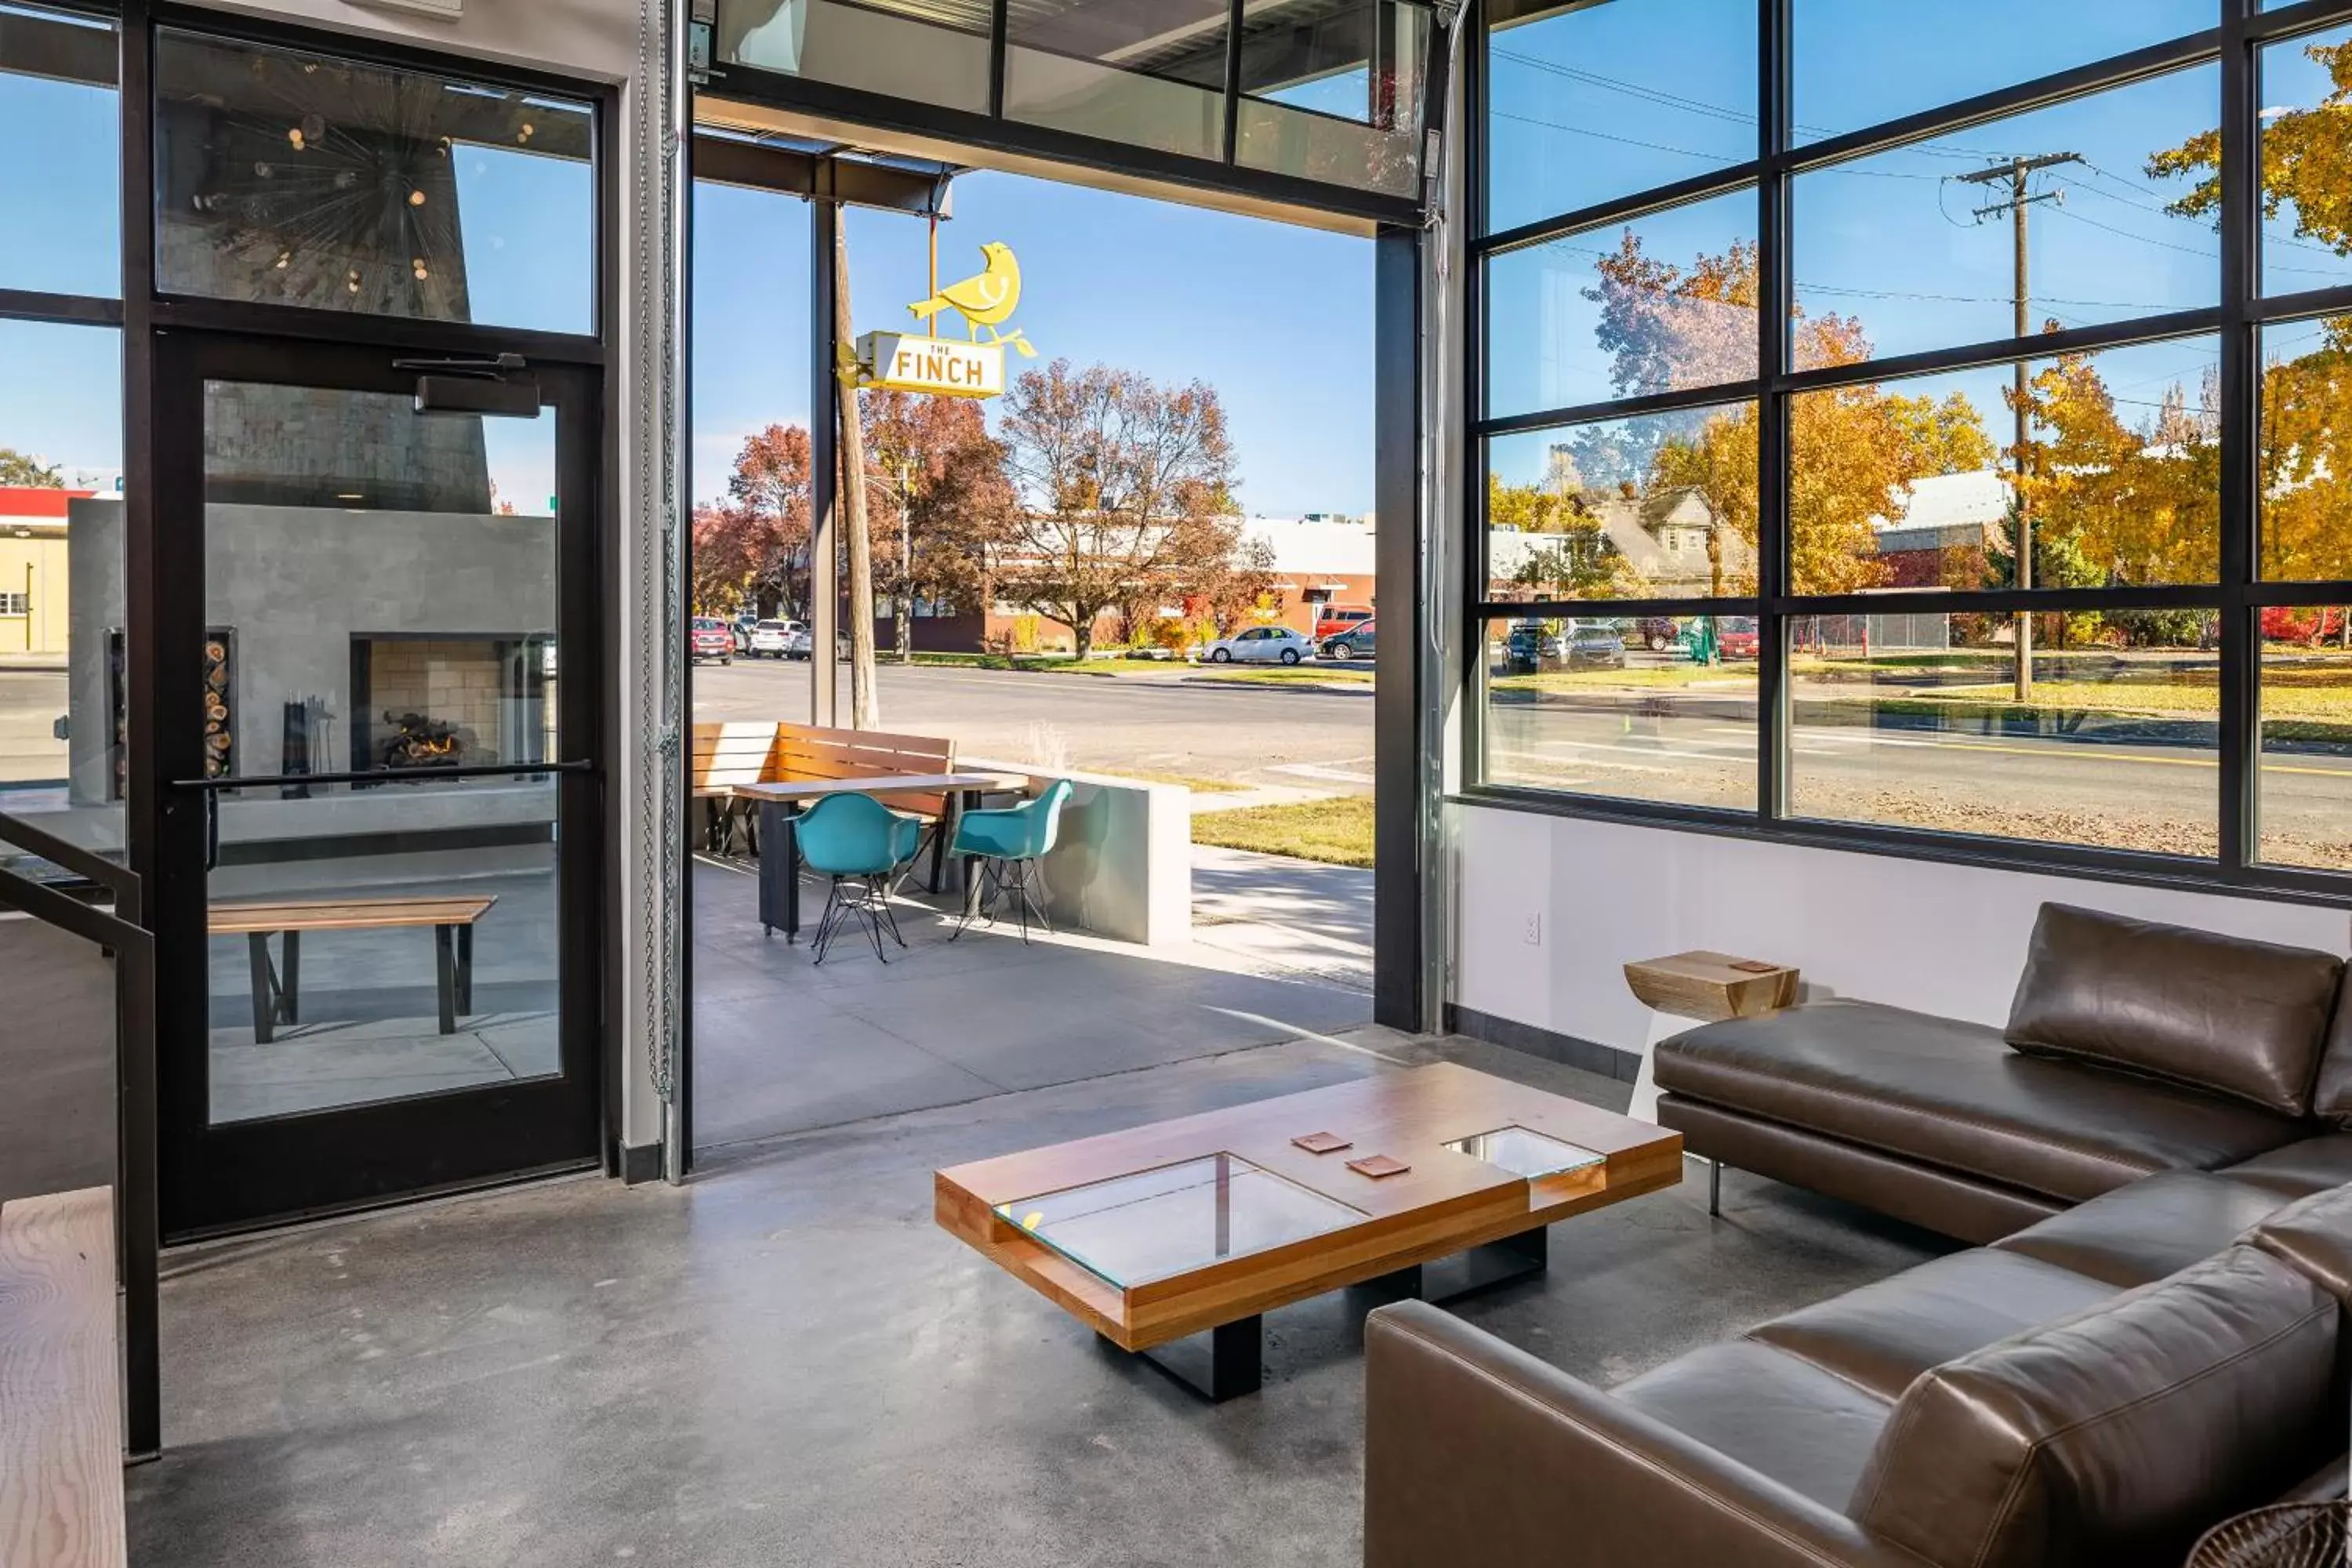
[957,757,1192,947]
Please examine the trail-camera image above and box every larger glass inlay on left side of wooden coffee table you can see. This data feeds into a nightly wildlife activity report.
[995,1154,1364,1290]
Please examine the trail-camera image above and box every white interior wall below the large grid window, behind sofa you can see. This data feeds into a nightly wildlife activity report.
[1454,806,2347,1051]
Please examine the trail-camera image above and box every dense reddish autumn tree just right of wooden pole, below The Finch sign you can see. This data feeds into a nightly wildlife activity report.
[858,390,1016,663]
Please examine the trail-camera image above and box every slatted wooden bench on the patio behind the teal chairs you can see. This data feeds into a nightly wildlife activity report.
[694,722,955,893]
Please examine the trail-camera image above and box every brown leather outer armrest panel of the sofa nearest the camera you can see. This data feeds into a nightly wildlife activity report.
[1364,1302,1924,1568]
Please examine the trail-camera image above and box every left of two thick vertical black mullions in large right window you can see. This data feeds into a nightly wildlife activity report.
[1757,0,1795,822]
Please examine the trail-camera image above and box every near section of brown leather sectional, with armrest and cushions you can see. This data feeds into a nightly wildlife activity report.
[1364,1161,2352,1568]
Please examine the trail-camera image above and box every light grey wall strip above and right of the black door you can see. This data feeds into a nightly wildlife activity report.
[170,0,682,1145]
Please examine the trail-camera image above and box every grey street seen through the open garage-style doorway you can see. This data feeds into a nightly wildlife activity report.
[694,659,1371,794]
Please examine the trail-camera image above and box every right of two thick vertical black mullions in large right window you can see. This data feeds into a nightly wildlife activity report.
[2220,0,2263,869]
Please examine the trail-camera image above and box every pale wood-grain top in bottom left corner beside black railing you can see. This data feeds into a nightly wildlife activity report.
[0,1187,129,1568]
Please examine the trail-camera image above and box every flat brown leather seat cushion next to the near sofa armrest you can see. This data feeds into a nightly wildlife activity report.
[1611,1340,1891,1512]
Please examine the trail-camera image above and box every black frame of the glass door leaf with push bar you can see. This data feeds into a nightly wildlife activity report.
[143,329,609,1239]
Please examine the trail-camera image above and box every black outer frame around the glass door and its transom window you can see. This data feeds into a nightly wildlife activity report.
[101,0,626,1239]
